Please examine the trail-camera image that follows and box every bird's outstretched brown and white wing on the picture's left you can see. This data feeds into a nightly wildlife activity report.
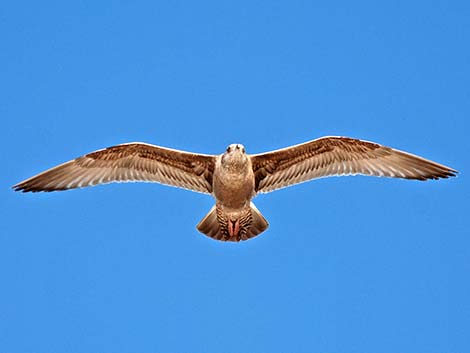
[13,143,215,193]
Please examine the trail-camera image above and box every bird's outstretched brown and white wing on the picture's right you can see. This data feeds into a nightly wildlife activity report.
[251,136,457,193]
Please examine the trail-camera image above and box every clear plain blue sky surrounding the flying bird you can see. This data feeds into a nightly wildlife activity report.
[0,1,470,353]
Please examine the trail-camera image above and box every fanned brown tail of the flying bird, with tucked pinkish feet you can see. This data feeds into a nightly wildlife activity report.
[197,203,269,242]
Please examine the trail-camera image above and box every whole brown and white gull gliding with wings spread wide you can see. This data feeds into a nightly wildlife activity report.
[13,136,457,242]
